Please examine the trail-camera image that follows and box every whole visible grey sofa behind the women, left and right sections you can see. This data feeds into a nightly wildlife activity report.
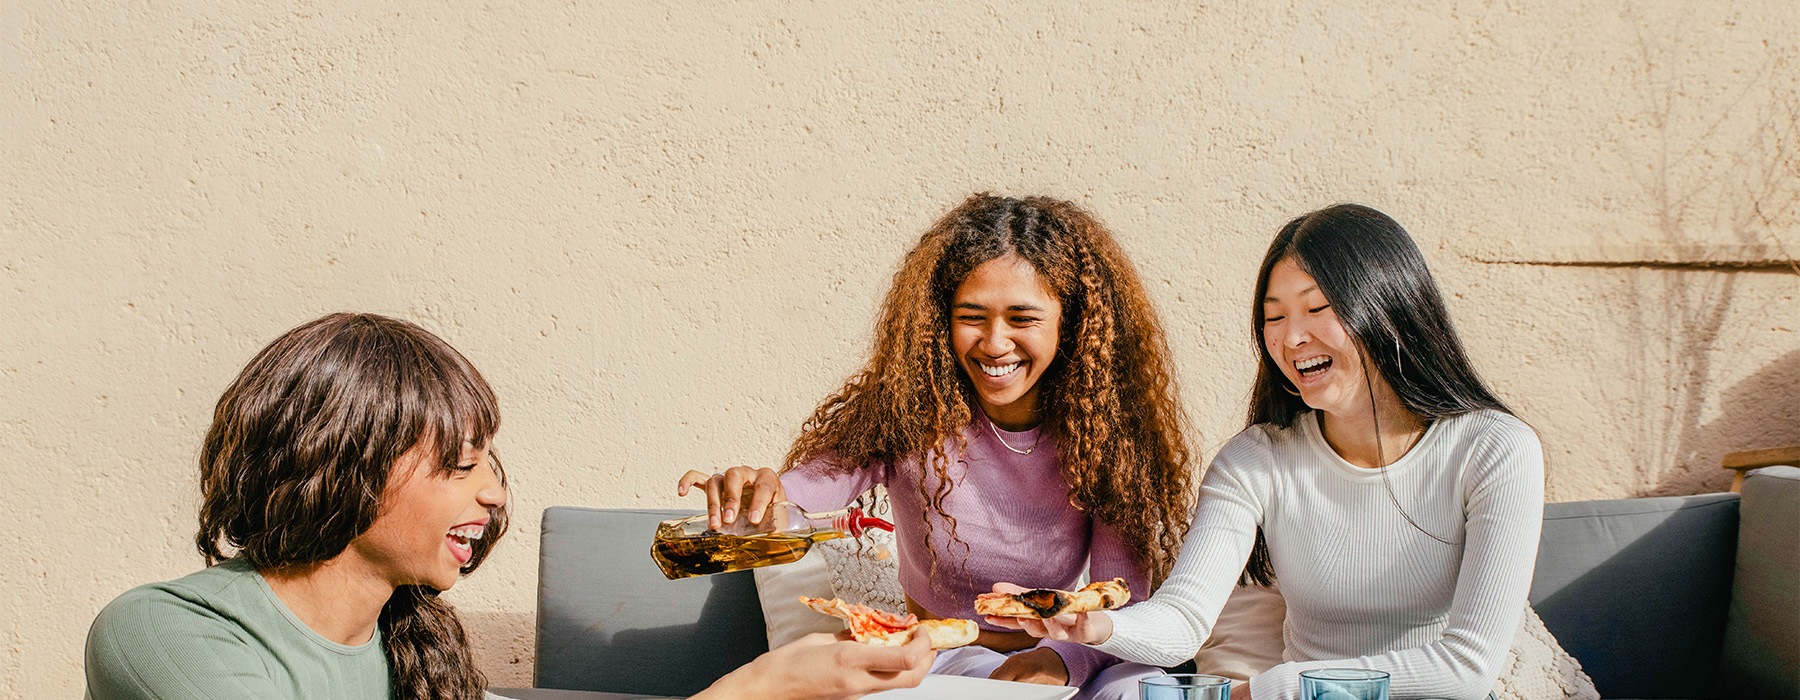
[497,466,1800,700]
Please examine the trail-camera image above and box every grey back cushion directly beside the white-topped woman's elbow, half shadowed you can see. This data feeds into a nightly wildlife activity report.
[1530,493,1737,698]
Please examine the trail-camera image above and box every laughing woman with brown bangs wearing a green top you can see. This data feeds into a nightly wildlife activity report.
[86,313,931,700]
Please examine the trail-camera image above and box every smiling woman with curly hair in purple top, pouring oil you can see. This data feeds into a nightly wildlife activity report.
[679,194,1193,696]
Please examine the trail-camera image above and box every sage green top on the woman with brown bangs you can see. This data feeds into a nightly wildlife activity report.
[86,560,392,700]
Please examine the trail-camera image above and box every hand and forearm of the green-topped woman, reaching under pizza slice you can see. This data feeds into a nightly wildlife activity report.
[693,632,936,700]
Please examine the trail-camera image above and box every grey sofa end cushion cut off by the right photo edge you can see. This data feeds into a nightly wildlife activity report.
[1719,466,1800,700]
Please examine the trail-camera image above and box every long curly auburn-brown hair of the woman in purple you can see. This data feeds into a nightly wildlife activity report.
[783,193,1193,581]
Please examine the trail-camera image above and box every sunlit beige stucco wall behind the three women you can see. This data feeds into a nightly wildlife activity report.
[0,0,1800,698]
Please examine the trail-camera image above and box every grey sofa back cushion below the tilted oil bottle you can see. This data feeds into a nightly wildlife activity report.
[536,506,769,696]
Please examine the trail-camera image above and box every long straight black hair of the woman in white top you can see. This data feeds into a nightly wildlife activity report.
[1240,203,1512,585]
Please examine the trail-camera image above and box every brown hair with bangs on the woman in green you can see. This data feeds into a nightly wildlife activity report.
[194,313,506,700]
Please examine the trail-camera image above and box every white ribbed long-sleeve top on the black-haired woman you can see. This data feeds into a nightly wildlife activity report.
[1096,410,1544,700]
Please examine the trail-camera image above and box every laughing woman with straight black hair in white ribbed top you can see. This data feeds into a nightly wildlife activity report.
[994,205,1544,700]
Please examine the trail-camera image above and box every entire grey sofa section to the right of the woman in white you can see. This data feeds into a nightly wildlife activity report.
[1530,466,1800,700]
